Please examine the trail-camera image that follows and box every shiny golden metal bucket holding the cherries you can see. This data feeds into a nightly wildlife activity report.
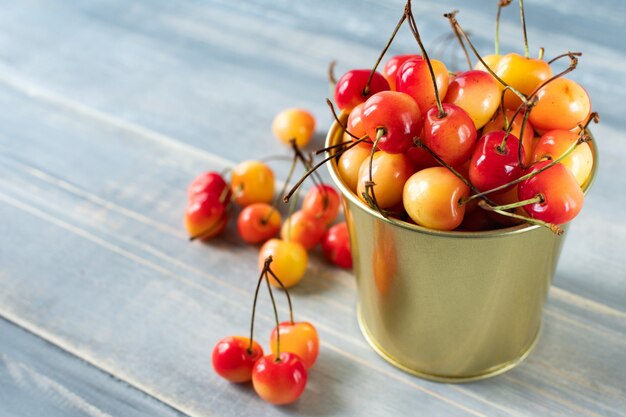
[326,117,597,382]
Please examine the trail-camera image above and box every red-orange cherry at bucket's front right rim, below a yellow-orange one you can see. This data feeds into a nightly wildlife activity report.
[517,161,584,225]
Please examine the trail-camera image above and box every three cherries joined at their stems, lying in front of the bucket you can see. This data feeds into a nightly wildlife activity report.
[212,256,319,404]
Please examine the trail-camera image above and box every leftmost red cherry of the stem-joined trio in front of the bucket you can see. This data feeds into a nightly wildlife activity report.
[212,336,263,383]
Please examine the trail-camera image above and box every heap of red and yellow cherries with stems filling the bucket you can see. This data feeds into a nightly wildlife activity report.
[331,0,597,233]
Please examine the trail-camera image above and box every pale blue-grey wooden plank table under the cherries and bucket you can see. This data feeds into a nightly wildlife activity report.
[0,0,626,417]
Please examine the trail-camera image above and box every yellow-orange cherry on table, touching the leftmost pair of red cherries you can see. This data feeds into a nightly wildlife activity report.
[230,161,274,207]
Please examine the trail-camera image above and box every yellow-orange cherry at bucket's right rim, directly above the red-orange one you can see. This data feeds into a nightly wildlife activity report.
[533,130,593,186]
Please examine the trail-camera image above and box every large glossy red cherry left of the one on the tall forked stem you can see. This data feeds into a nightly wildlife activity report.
[361,91,422,153]
